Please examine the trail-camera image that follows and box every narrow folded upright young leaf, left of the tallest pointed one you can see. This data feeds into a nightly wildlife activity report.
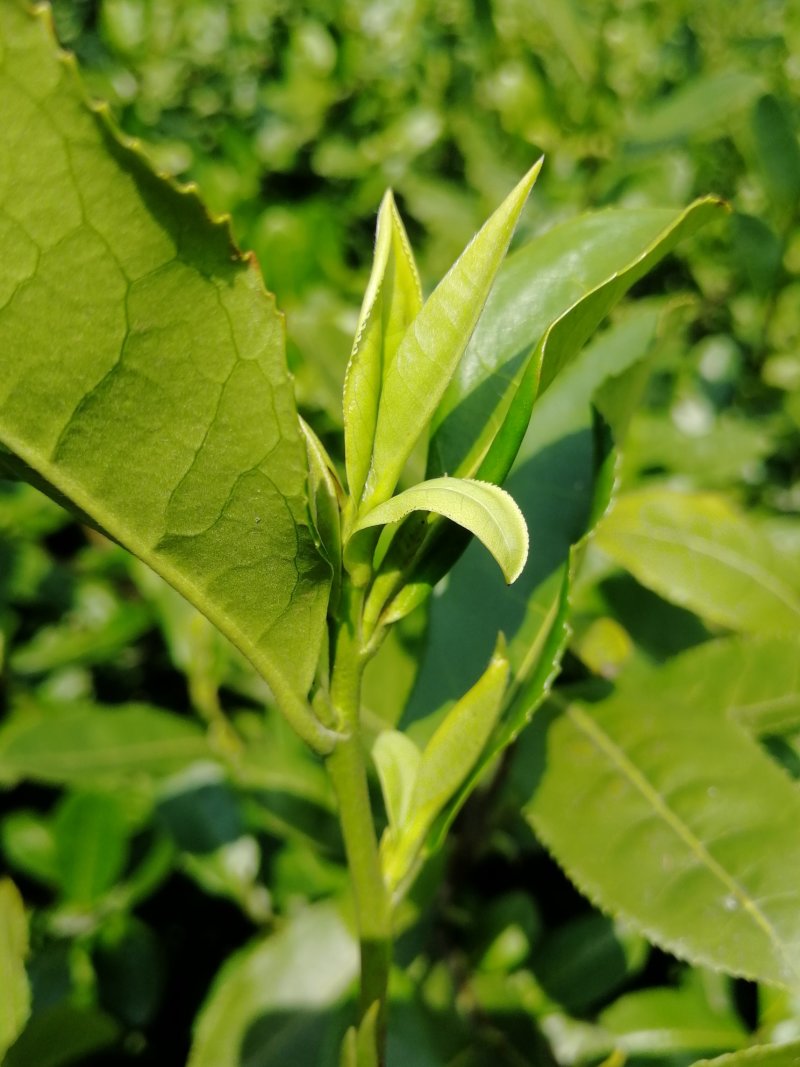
[343,192,422,503]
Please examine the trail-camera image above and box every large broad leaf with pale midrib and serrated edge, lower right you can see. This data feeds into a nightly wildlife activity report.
[516,641,800,987]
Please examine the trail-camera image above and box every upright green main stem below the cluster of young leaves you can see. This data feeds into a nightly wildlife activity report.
[325,583,391,1063]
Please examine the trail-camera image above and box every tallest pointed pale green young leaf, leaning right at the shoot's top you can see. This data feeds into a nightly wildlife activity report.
[364,160,542,509]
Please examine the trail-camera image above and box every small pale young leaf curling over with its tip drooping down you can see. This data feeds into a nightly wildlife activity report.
[355,478,528,585]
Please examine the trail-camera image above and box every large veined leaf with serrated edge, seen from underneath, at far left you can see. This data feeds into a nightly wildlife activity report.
[0,2,330,736]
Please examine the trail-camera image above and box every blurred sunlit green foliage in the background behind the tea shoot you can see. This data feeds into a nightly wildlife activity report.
[0,0,800,1067]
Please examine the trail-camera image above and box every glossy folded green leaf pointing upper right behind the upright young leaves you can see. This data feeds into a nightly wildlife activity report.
[429,201,719,481]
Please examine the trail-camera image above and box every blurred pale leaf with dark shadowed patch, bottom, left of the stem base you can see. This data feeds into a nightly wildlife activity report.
[188,903,358,1067]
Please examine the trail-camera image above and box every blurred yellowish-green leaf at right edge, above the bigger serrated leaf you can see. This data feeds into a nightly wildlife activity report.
[596,485,800,634]
